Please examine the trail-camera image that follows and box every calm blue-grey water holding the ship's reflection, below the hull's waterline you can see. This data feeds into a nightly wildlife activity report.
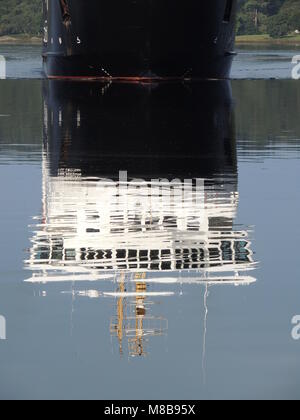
[0,76,300,399]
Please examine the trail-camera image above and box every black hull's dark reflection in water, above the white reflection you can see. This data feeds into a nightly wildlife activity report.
[44,80,237,182]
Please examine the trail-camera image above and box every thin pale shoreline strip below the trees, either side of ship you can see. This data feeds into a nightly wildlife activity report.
[0,35,300,47]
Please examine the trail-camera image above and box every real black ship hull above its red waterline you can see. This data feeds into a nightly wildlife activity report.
[43,0,237,80]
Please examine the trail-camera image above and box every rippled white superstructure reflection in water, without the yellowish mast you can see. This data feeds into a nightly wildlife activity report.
[27,162,254,283]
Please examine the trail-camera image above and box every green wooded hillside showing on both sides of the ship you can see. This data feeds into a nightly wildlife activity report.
[0,0,300,37]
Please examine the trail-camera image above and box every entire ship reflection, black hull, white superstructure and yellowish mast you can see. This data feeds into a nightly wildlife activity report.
[26,81,255,355]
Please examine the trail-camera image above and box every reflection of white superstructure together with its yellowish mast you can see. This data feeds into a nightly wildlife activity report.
[26,159,255,357]
